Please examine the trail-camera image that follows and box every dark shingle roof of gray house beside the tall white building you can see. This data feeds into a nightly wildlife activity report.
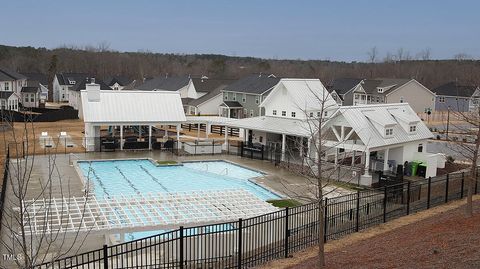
[224,74,280,94]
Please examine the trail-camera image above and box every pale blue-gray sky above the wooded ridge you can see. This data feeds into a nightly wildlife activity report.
[0,0,480,61]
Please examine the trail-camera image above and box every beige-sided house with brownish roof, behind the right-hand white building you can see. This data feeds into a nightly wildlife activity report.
[329,78,435,113]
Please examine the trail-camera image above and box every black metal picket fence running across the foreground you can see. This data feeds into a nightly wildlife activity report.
[35,168,479,268]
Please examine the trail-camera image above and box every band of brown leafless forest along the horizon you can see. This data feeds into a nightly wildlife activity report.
[0,43,480,88]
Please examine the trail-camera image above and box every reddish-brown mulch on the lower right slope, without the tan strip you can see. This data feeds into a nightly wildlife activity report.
[289,200,480,269]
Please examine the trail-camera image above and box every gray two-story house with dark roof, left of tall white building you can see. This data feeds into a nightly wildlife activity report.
[219,74,280,119]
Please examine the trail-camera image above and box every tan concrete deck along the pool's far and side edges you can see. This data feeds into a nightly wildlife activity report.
[20,151,349,199]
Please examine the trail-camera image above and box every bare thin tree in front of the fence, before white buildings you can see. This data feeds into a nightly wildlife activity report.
[283,88,360,268]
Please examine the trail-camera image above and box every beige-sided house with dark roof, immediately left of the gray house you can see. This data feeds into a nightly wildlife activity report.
[182,76,233,115]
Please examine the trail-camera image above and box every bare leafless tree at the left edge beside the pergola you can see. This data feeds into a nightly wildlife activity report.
[0,113,93,268]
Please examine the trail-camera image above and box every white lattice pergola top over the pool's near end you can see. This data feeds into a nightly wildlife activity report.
[23,189,278,234]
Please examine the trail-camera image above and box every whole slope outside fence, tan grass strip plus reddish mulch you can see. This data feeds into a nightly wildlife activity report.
[263,196,480,269]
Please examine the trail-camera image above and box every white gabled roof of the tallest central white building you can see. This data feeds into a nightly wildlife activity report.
[260,78,338,111]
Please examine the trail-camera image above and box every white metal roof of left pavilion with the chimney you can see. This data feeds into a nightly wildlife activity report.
[80,90,186,124]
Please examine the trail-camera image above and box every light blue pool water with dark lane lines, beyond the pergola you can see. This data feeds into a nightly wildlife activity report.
[78,159,279,200]
